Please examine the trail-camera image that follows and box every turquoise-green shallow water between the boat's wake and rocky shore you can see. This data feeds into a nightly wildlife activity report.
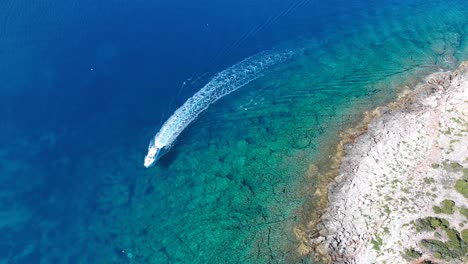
[89,3,468,263]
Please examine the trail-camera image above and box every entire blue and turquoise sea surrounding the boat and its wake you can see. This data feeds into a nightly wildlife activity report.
[0,0,468,263]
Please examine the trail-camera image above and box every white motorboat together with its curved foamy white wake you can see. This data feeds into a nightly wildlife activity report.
[144,50,293,168]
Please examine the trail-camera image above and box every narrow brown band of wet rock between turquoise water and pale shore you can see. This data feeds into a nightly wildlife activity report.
[292,62,460,262]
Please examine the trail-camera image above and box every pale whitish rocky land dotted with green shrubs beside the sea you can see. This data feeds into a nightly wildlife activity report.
[311,63,468,263]
